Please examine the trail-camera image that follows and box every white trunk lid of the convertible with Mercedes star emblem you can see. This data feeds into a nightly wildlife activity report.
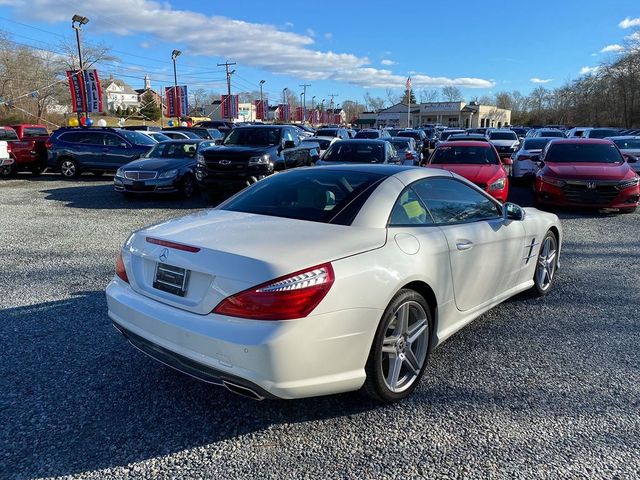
[123,210,386,315]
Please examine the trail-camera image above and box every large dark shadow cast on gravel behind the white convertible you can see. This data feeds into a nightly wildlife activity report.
[0,291,377,478]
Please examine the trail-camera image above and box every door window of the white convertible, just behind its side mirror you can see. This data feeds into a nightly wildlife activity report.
[413,178,502,224]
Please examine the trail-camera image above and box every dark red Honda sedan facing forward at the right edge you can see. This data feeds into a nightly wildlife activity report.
[535,139,640,213]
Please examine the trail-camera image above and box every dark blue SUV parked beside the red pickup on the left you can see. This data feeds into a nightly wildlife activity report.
[47,127,156,178]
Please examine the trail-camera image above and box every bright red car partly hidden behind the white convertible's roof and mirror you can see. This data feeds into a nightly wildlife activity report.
[428,141,509,202]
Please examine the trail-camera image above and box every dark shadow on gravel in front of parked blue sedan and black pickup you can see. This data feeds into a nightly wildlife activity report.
[41,184,213,210]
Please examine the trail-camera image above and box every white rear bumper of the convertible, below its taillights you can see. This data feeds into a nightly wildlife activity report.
[106,278,382,399]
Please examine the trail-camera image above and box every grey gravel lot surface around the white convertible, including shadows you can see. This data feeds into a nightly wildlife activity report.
[0,175,640,479]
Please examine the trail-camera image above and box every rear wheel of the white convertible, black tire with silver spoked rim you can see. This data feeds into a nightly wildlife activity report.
[362,289,433,403]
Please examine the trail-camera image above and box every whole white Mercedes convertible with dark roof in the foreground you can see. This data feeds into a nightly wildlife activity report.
[107,165,562,402]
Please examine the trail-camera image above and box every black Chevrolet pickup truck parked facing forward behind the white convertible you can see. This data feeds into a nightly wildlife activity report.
[196,125,319,195]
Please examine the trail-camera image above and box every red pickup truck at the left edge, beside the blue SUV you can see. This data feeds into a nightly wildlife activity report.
[0,124,49,176]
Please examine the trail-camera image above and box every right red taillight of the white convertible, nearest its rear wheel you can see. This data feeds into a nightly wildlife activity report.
[213,263,334,320]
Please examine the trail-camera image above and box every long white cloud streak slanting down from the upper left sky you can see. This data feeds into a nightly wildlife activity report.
[0,0,495,88]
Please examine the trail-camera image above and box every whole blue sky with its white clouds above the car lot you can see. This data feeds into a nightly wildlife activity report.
[0,0,640,103]
